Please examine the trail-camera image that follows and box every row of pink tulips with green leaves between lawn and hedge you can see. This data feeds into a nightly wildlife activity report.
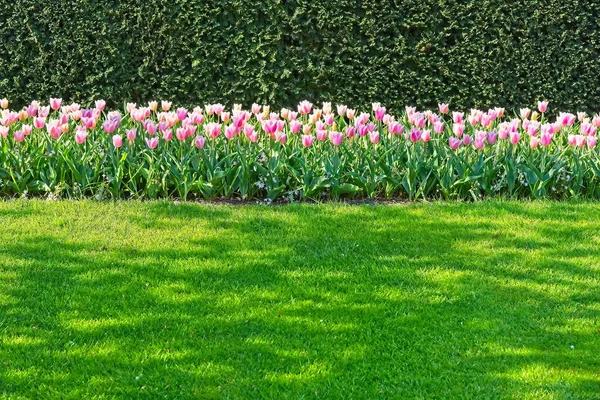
[0,98,600,201]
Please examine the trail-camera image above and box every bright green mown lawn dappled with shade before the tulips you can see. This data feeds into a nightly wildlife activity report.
[0,201,600,399]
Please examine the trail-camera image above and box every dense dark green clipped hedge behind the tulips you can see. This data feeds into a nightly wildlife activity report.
[0,0,600,111]
